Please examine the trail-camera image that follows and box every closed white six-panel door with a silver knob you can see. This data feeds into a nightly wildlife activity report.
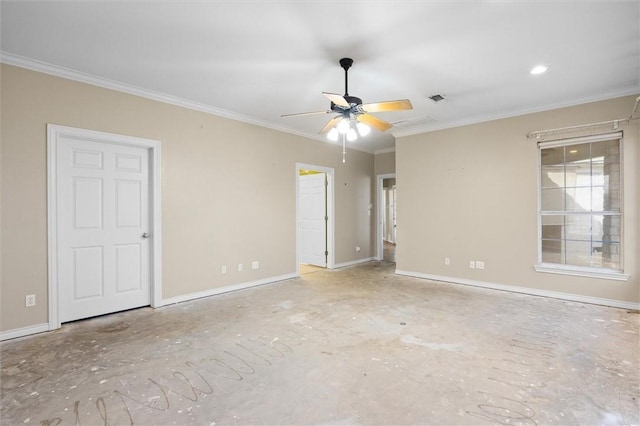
[57,137,151,322]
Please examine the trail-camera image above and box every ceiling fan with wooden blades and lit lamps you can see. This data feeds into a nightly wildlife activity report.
[282,58,413,140]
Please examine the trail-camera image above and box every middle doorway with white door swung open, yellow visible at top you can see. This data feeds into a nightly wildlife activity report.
[296,163,334,274]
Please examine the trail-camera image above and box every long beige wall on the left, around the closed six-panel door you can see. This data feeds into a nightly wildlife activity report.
[0,65,374,331]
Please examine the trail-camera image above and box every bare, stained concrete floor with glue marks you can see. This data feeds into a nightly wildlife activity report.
[0,262,640,425]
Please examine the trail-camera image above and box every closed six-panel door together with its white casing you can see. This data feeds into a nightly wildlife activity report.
[47,125,161,330]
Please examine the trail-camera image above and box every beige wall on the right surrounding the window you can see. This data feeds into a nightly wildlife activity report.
[396,96,640,303]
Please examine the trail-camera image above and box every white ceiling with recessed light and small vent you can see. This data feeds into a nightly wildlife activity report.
[0,0,640,152]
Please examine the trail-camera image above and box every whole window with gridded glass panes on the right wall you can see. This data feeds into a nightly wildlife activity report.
[536,132,624,279]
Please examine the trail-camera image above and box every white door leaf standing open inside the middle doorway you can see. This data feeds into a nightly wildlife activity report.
[298,173,327,267]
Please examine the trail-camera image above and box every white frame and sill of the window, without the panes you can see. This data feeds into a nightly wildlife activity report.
[534,131,630,281]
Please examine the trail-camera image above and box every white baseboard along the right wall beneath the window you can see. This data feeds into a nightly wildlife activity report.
[396,269,640,311]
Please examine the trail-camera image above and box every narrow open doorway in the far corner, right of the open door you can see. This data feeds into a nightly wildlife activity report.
[377,173,397,263]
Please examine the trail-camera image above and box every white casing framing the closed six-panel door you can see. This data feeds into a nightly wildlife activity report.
[47,124,162,330]
